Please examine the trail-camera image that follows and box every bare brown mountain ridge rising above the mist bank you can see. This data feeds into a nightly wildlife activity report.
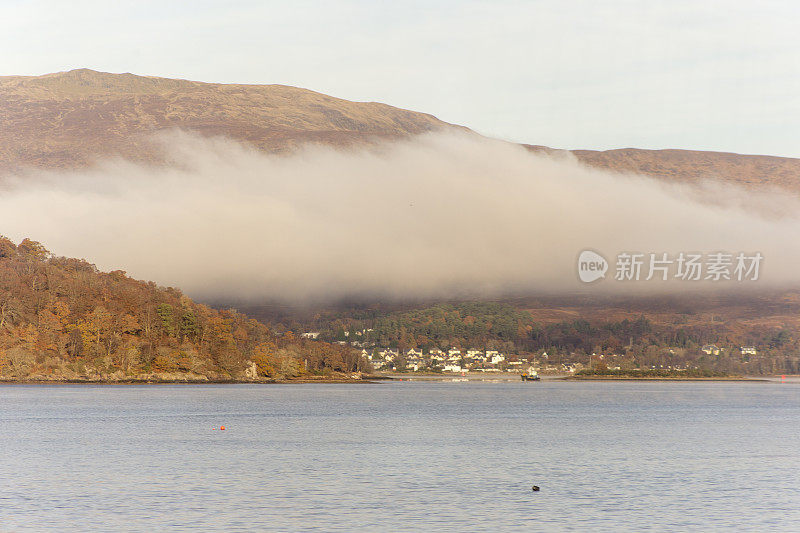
[0,69,800,193]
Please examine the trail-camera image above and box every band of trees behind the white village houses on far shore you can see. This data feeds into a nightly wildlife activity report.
[315,302,800,373]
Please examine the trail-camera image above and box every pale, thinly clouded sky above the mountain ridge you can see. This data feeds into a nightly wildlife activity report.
[0,0,800,157]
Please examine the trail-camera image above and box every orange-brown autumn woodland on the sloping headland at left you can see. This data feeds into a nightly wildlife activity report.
[0,237,366,381]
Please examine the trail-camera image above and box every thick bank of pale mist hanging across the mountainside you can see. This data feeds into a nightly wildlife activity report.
[0,132,800,302]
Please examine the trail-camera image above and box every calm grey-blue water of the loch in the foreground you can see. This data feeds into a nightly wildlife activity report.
[0,382,800,531]
